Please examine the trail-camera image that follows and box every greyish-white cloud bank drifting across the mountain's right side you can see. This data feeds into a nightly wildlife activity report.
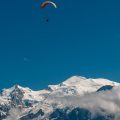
[49,87,120,120]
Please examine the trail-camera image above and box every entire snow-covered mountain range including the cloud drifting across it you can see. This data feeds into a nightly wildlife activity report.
[0,76,120,120]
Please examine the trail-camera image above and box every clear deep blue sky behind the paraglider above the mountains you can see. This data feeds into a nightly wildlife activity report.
[0,0,120,89]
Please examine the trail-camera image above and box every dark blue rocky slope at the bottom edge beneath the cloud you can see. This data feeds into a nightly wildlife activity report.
[49,108,115,120]
